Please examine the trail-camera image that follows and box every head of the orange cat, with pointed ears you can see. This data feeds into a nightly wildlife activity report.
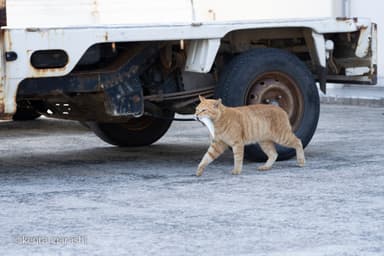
[195,96,223,121]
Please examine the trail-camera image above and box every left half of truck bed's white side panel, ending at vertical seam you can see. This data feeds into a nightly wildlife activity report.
[7,0,192,27]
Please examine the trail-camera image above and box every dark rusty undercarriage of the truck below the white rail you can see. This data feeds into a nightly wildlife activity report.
[13,21,377,122]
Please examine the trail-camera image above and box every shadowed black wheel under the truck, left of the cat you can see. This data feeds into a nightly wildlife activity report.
[87,112,174,147]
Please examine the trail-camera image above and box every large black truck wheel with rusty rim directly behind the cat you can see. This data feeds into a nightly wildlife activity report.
[215,48,320,161]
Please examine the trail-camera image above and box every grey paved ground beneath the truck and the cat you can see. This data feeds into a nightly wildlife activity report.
[0,105,384,256]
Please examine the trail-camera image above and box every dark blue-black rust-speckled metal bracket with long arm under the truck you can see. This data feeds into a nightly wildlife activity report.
[15,46,159,117]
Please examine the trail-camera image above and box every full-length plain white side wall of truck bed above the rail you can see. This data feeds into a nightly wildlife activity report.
[7,0,334,27]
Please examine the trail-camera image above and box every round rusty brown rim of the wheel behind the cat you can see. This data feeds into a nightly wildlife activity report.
[246,71,304,131]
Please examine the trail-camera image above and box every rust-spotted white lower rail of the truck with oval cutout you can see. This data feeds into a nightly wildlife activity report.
[4,19,370,78]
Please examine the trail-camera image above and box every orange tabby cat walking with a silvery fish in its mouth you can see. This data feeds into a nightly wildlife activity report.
[195,96,305,176]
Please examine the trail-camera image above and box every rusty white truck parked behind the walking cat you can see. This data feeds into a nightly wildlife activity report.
[0,0,377,160]
